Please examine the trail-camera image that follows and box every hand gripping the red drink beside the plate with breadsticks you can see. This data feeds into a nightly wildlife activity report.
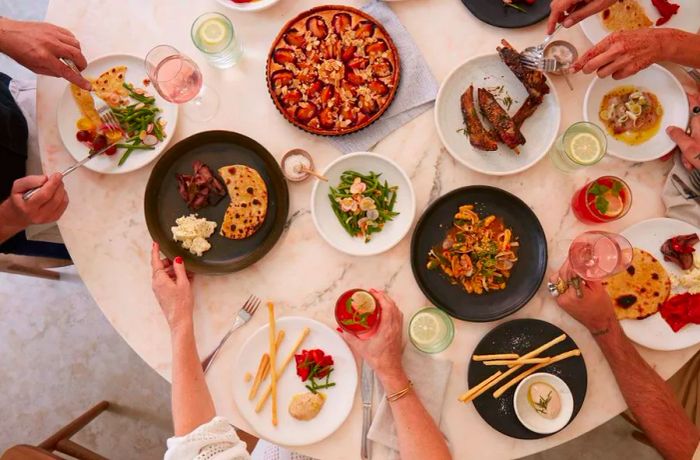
[342,289,403,380]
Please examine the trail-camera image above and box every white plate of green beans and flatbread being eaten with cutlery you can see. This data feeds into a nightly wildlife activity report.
[56,54,178,174]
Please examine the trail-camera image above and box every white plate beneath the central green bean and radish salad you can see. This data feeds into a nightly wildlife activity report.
[311,152,416,256]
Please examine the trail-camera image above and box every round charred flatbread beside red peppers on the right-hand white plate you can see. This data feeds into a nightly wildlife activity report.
[603,248,671,319]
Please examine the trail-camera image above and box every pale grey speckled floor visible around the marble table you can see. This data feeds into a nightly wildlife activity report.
[0,0,660,460]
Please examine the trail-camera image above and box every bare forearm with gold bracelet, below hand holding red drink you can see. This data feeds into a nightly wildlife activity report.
[379,371,452,460]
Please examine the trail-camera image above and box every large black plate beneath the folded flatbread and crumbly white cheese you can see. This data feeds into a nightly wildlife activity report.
[144,131,289,274]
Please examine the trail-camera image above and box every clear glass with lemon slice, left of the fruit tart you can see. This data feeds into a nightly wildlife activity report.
[190,13,243,69]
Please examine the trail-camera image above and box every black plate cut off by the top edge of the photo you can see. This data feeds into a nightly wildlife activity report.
[462,0,550,29]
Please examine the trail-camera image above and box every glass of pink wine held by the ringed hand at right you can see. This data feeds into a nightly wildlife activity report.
[569,231,633,281]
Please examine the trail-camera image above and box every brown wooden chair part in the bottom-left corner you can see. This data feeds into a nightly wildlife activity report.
[0,401,109,460]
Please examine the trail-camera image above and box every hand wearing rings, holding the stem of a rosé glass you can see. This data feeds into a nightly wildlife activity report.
[550,261,617,334]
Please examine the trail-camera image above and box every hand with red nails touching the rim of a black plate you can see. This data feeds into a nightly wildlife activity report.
[151,242,194,333]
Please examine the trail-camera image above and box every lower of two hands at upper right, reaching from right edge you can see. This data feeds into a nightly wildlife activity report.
[571,29,667,80]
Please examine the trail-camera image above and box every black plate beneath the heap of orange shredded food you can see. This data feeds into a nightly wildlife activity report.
[411,185,547,321]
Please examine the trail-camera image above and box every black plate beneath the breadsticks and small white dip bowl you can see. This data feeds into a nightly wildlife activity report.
[467,319,588,439]
